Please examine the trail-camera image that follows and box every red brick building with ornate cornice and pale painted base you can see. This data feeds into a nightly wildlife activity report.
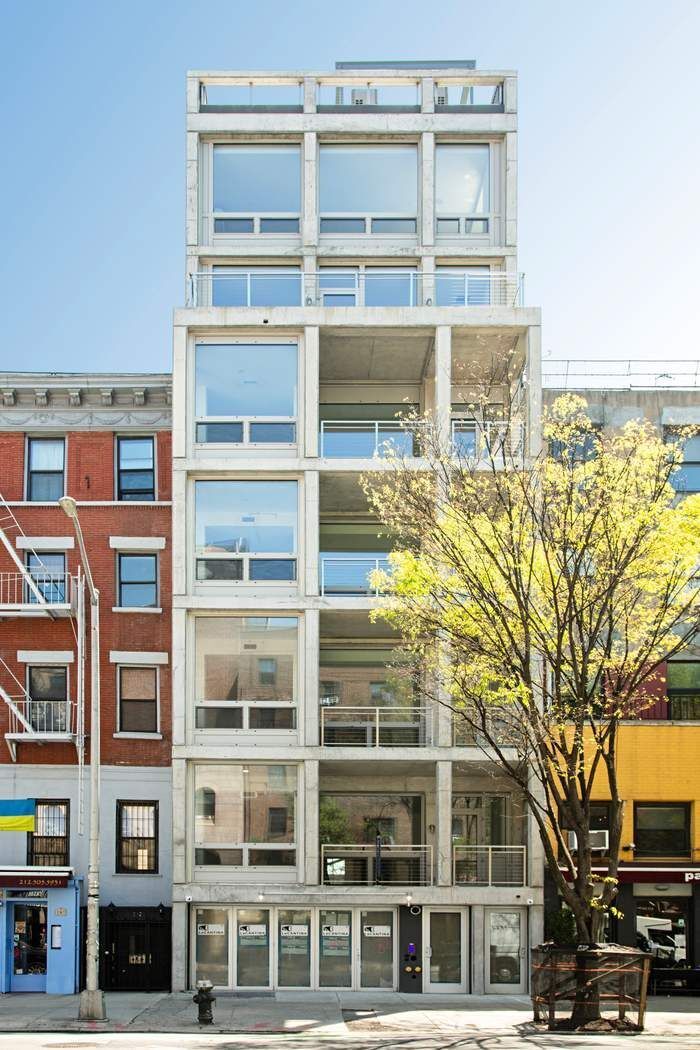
[0,373,171,992]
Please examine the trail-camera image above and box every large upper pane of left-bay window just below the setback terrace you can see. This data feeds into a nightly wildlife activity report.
[195,343,297,422]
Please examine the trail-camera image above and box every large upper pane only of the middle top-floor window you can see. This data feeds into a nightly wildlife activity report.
[319,144,418,215]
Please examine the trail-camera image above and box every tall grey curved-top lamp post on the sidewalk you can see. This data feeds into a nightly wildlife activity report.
[59,496,106,1021]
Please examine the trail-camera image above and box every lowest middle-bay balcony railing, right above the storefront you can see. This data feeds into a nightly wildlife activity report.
[321,843,432,886]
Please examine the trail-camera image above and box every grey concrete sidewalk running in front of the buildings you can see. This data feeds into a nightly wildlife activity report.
[0,992,700,1046]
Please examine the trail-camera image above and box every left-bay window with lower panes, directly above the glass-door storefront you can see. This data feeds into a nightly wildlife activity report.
[194,762,297,867]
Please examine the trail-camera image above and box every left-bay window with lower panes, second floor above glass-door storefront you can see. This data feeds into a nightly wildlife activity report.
[195,616,298,730]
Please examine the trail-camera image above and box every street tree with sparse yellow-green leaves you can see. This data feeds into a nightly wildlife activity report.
[364,395,700,1016]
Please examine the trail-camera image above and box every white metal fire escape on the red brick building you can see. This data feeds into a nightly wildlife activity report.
[0,495,85,764]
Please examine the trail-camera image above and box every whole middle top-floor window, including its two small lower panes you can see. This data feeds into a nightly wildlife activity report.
[319,144,418,234]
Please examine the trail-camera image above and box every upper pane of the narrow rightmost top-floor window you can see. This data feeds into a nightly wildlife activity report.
[436,144,490,215]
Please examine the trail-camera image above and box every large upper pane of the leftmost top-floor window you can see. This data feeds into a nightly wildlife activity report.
[214,145,301,214]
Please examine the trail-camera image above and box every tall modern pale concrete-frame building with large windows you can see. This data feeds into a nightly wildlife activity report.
[172,62,543,993]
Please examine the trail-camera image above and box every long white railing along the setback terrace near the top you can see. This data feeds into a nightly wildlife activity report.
[187,269,523,308]
